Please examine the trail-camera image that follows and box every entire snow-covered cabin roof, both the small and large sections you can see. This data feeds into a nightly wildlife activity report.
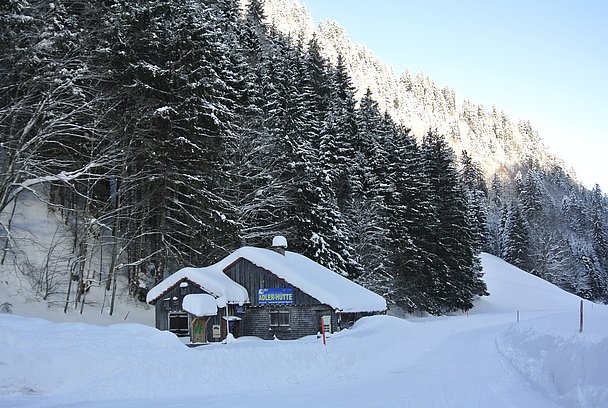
[147,247,386,313]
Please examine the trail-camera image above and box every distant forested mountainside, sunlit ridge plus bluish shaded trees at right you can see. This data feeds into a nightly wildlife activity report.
[265,0,608,301]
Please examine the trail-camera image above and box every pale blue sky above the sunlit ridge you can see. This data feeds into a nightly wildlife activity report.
[300,0,608,193]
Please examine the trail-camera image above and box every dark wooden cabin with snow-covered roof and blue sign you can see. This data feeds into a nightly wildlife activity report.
[147,237,386,341]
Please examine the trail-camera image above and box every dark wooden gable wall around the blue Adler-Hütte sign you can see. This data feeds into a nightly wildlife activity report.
[224,258,338,340]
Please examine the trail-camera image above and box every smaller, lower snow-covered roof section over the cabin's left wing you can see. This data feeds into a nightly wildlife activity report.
[146,263,249,307]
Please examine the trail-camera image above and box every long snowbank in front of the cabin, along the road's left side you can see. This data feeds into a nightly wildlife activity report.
[0,314,411,406]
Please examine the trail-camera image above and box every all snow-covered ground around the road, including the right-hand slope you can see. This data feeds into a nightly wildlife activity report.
[0,255,608,408]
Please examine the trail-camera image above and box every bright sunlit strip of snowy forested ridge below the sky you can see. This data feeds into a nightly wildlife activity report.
[265,0,573,177]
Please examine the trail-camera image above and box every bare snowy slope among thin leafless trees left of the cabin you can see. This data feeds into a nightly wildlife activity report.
[0,192,154,324]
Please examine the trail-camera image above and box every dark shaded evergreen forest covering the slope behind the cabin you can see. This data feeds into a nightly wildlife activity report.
[0,0,608,314]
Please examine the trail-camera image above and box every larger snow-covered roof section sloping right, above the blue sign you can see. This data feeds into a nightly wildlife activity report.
[219,247,386,313]
